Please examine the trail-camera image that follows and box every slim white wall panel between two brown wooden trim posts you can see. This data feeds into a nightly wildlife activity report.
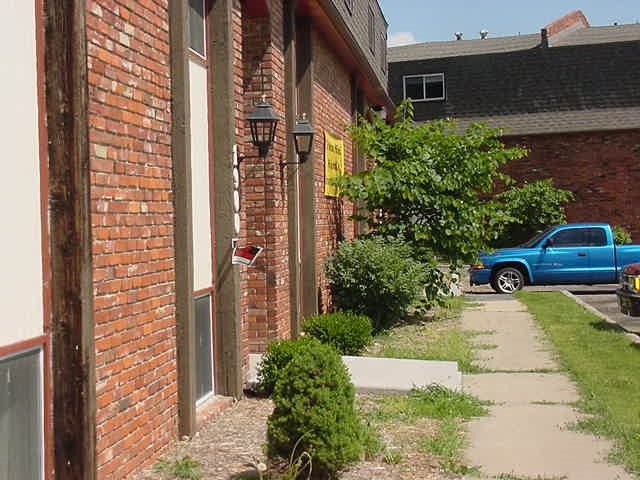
[189,61,212,290]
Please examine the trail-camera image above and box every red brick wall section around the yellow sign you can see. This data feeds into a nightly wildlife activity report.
[313,33,354,311]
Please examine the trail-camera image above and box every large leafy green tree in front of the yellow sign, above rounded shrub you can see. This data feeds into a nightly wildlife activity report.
[337,101,526,265]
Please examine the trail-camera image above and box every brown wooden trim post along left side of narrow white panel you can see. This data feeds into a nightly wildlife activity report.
[169,0,196,436]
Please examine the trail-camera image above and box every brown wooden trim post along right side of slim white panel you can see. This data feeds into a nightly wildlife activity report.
[208,0,243,398]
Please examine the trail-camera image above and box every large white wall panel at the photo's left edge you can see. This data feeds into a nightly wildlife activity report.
[0,0,43,345]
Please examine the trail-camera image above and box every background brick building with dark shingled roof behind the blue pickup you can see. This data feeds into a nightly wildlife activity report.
[389,11,640,242]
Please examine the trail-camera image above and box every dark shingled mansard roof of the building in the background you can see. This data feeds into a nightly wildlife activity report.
[389,24,640,135]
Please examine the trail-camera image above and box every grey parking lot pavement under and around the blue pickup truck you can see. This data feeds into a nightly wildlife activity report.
[465,284,640,336]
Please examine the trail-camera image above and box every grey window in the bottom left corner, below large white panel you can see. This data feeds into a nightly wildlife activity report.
[0,349,43,480]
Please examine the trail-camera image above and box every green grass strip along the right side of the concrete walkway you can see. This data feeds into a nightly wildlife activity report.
[517,292,640,475]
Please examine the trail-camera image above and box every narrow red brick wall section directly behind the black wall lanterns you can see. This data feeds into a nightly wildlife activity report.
[239,0,290,353]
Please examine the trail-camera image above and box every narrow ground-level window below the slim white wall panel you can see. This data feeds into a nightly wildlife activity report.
[195,295,213,400]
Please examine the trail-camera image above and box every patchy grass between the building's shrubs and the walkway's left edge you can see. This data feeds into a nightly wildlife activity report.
[358,297,487,474]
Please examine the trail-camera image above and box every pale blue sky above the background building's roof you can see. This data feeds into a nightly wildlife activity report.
[378,0,640,46]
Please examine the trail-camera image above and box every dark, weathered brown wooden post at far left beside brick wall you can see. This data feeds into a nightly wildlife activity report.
[44,0,96,480]
